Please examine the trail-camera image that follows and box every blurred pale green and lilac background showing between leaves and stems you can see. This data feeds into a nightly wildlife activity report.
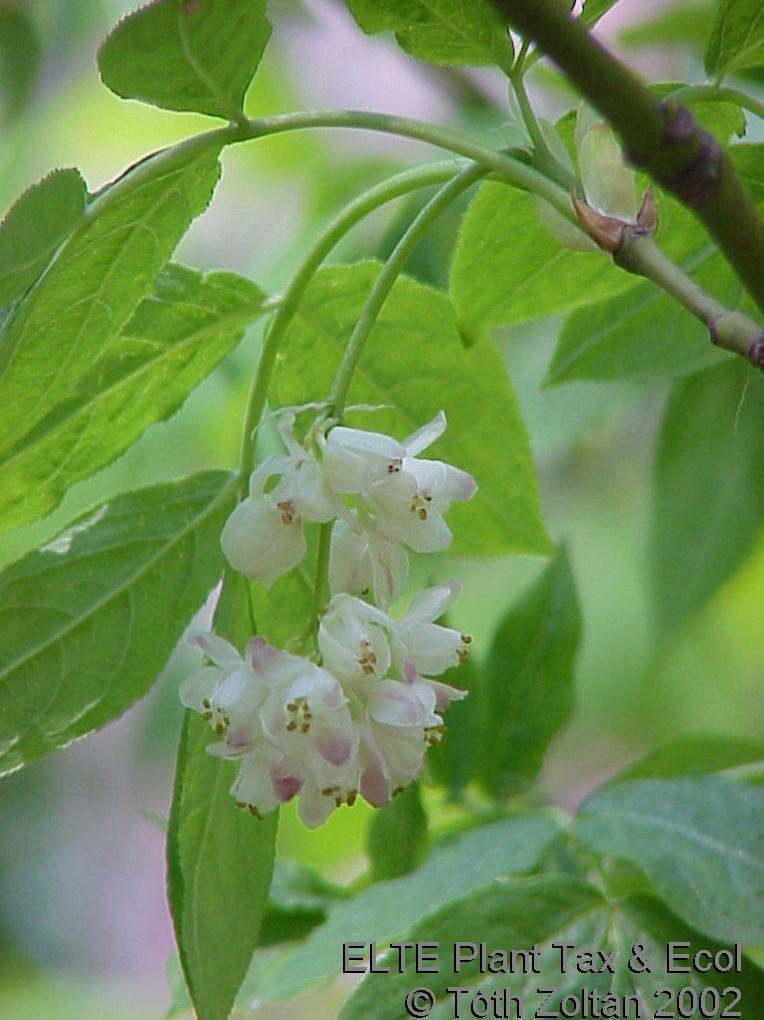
[0,0,764,1020]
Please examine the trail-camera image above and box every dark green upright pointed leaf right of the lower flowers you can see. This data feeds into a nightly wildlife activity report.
[480,550,581,800]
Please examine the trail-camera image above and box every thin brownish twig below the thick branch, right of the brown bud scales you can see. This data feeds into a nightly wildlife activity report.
[613,227,764,367]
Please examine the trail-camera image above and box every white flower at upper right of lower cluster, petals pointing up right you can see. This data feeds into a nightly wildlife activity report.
[393,580,471,685]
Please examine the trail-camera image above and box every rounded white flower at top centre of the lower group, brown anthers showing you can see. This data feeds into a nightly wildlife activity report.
[318,595,392,683]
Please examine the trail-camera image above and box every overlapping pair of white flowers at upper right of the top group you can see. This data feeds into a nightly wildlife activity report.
[323,411,476,553]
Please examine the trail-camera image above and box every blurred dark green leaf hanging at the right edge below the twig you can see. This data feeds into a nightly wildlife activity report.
[651,360,764,634]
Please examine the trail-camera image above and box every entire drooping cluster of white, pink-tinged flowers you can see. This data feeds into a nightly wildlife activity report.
[181,413,475,827]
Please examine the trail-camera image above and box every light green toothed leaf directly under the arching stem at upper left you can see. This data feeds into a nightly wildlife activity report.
[0,137,219,463]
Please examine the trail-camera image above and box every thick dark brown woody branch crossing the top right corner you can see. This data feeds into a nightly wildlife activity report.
[493,0,764,310]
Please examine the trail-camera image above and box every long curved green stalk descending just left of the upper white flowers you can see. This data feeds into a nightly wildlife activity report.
[236,160,471,496]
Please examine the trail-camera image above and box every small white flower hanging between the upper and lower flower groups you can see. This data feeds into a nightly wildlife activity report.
[328,517,409,606]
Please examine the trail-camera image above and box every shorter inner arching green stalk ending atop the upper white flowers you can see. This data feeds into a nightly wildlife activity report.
[328,165,488,418]
